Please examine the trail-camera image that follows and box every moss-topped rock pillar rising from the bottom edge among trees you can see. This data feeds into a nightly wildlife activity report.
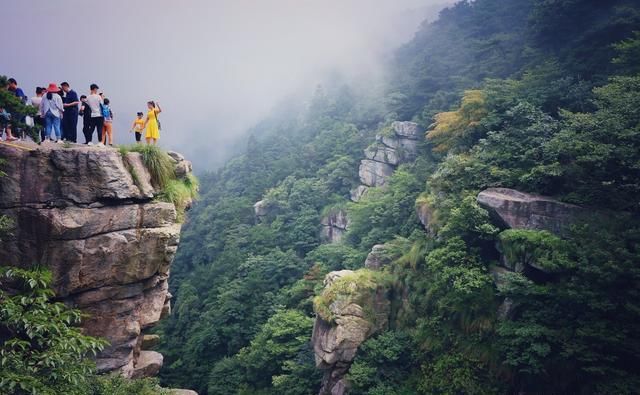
[311,270,390,395]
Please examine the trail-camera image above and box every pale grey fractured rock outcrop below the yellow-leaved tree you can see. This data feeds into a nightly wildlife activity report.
[351,122,421,202]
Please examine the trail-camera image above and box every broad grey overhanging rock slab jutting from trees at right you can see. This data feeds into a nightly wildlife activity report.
[477,188,583,234]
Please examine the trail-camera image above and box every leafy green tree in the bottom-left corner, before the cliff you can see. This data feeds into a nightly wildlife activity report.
[0,267,106,395]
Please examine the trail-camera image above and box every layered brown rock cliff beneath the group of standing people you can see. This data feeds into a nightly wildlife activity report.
[0,143,191,377]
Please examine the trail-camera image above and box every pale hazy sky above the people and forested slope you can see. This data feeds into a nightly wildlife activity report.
[0,0,452,170]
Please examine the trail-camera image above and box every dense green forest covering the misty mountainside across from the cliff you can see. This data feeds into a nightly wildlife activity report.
[158,0,640,395]
